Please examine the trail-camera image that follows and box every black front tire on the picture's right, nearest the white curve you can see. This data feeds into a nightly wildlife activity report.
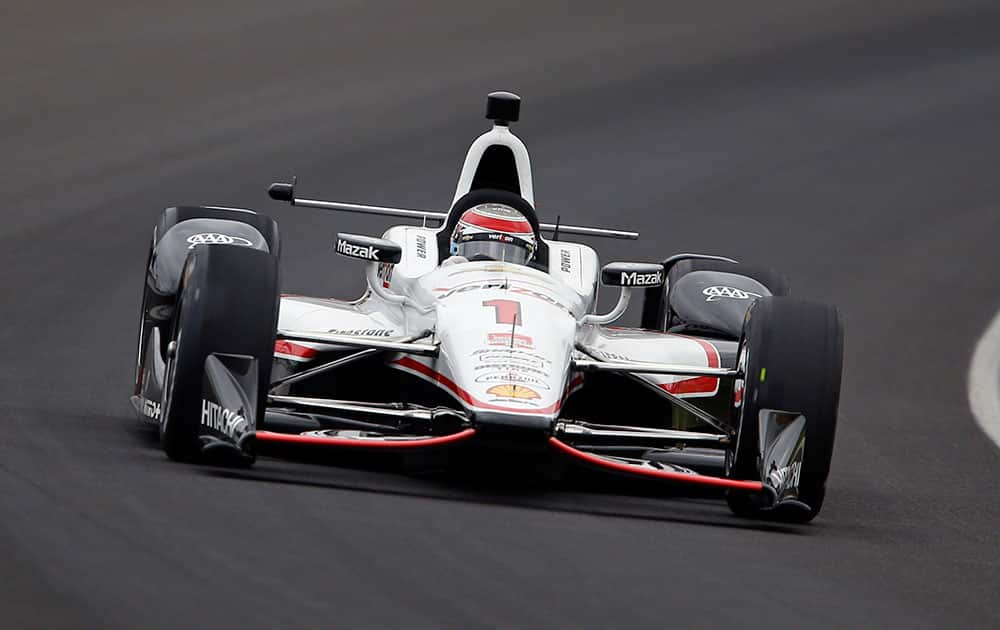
[726,297,844,522]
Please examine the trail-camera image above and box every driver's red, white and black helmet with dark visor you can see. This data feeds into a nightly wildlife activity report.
[451,203,538,265]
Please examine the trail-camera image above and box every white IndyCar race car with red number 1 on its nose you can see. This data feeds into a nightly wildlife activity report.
[132,92,843,522]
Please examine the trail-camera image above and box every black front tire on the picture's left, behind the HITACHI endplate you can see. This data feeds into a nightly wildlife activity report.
[160,245,279,461]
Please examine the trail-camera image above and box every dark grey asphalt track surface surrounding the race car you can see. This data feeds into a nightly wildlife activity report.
[0,0,1000,628]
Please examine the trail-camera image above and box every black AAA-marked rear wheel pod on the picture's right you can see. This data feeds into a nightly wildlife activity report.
[667,271,771,339]
